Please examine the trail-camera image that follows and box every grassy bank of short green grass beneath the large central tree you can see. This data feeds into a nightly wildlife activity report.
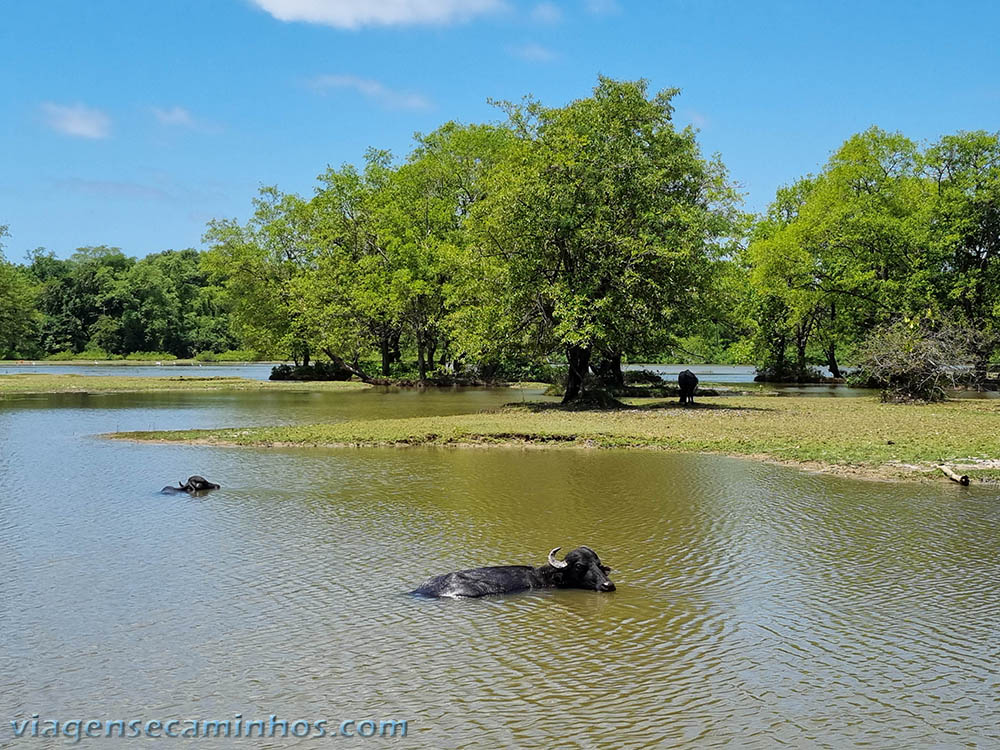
[109,396,1000,478]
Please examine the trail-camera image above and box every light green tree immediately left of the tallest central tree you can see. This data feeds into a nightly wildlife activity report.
[296,123,510,380]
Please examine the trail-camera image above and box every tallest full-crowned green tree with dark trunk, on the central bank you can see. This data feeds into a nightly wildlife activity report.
[473,78,736,402]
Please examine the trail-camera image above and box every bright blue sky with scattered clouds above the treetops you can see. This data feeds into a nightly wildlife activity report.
[0,0,1000,261]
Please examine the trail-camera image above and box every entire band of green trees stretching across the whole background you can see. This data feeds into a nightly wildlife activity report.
[0,78,1000,388]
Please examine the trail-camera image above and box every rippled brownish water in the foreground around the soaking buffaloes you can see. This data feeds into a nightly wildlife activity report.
[0,391,1000,748]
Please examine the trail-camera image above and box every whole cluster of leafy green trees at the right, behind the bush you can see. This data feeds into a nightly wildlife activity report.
[742,128,1000,379]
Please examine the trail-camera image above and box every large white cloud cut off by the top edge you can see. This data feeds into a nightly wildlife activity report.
[250,0,504,29]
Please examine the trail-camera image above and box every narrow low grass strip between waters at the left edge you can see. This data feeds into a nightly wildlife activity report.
[0,373,369,398]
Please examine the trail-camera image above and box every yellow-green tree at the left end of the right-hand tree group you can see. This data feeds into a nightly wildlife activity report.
[744,128,935,379]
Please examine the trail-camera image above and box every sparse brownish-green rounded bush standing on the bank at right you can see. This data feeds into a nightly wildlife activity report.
[852,321,976,402]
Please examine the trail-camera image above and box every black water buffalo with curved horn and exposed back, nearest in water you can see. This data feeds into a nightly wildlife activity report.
[411,547,615,597]
